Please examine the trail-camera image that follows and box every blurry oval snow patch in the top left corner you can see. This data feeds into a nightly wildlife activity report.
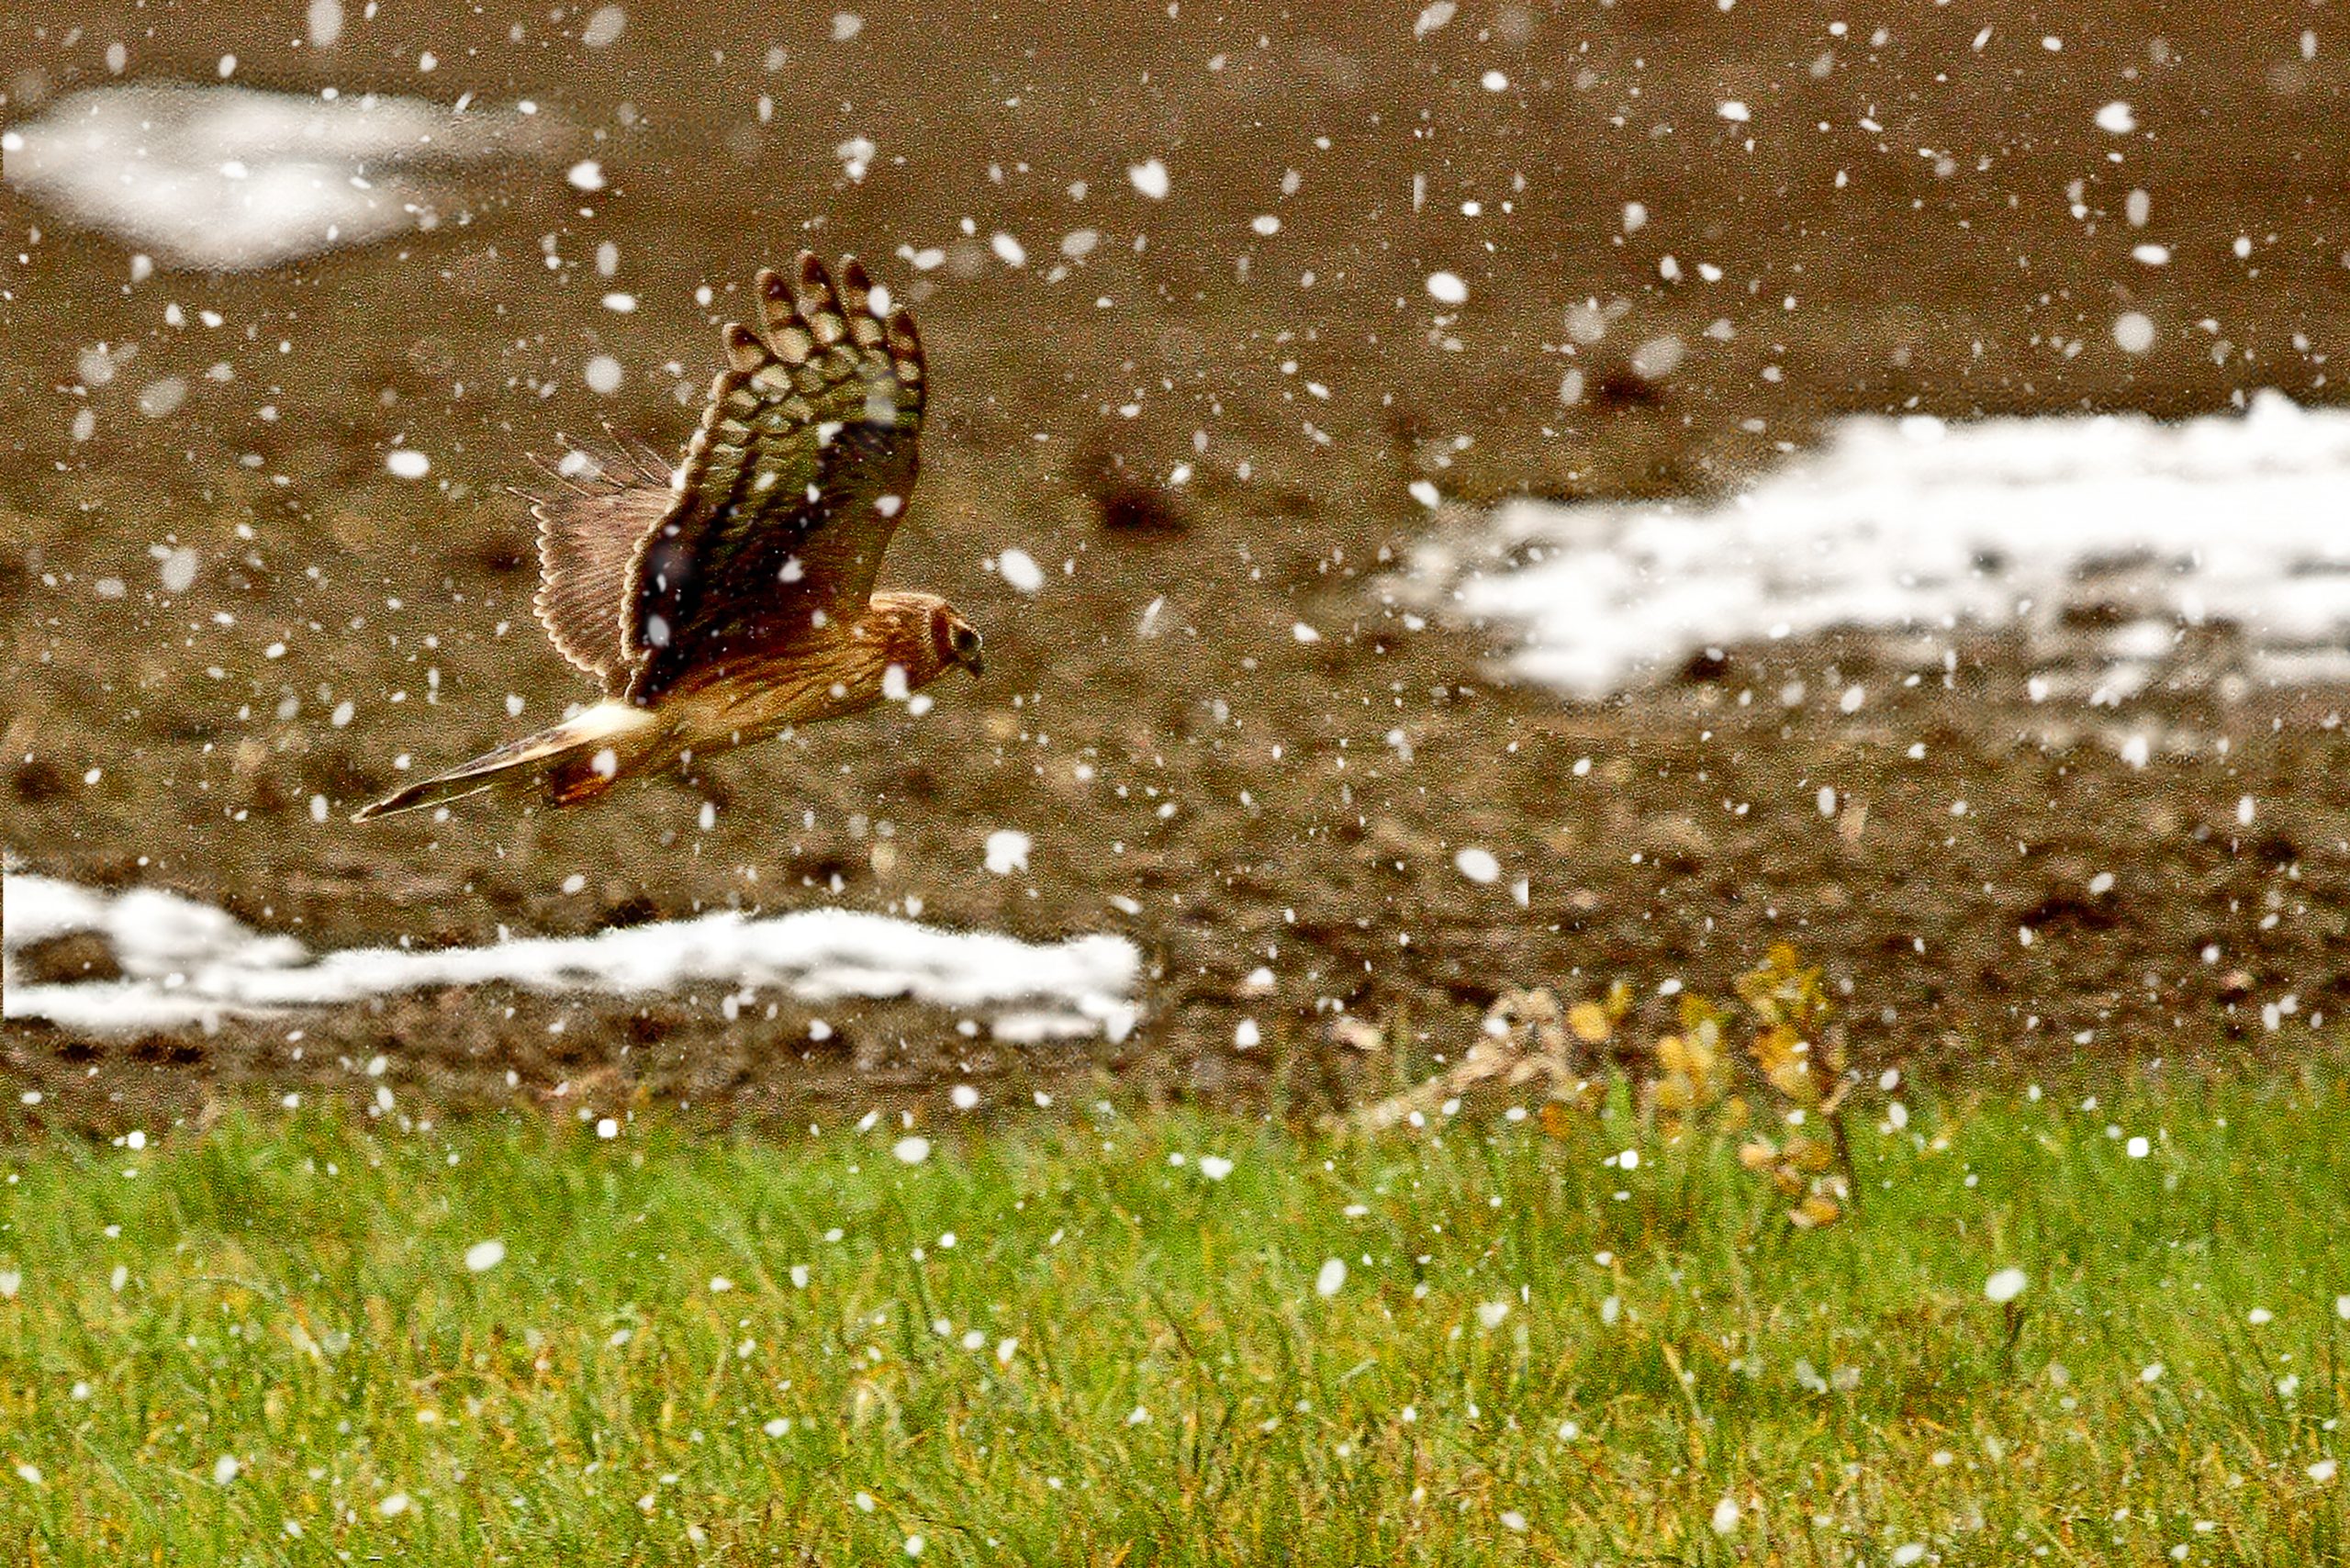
[5,83,566,273]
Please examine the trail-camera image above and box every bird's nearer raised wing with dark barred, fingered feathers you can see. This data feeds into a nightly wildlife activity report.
[618,252,923,705]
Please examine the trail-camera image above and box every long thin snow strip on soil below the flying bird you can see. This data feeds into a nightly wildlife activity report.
[0,875,1142,1044]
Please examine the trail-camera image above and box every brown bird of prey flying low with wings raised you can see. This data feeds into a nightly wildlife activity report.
[352,252,982,821]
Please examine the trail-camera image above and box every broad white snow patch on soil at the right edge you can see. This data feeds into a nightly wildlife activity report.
[1413,393,2350,703]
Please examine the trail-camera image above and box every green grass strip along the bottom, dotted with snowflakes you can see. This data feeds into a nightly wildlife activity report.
[0,1072,2350,1565]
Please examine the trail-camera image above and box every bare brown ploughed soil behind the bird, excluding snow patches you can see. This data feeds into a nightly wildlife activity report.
[0,0,2350,1124]
